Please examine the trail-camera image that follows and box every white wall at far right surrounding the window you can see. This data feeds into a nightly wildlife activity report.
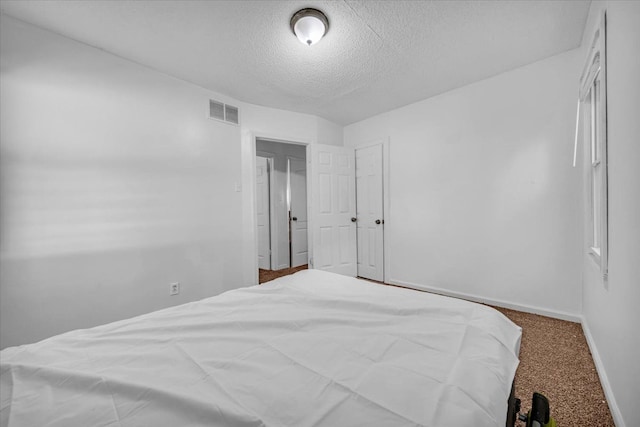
[581,1,640,427]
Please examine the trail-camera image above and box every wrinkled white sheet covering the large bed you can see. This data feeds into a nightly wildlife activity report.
[0,270,521,427]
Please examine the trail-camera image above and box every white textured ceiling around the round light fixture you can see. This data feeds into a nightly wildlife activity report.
[1,0,590,124]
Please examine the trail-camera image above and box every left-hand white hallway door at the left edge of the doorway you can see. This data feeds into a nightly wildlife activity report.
[256,157,271,270]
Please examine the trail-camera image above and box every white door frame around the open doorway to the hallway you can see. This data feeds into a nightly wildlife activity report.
[249,132,313,284]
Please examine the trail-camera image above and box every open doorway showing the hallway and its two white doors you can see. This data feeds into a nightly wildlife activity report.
[256,138,309,283]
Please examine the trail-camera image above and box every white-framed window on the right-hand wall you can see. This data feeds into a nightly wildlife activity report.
[580,10,607,280]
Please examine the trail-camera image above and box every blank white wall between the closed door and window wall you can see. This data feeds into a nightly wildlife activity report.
[345,51,582,319]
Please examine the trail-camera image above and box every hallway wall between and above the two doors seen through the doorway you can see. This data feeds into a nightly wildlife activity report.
[256,140,307,270]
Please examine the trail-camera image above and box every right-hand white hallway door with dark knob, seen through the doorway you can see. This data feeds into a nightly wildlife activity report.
[289,157,309,267]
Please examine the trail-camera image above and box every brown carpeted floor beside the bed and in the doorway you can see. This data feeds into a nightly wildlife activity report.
[260,265,615,427]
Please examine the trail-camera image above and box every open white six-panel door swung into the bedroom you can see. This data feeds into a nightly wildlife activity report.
[311,144,357,276]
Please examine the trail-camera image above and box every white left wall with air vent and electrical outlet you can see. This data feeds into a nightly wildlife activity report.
[0,15,342,348]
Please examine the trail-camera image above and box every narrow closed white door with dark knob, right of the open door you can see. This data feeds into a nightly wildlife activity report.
[356,144,384,282]
